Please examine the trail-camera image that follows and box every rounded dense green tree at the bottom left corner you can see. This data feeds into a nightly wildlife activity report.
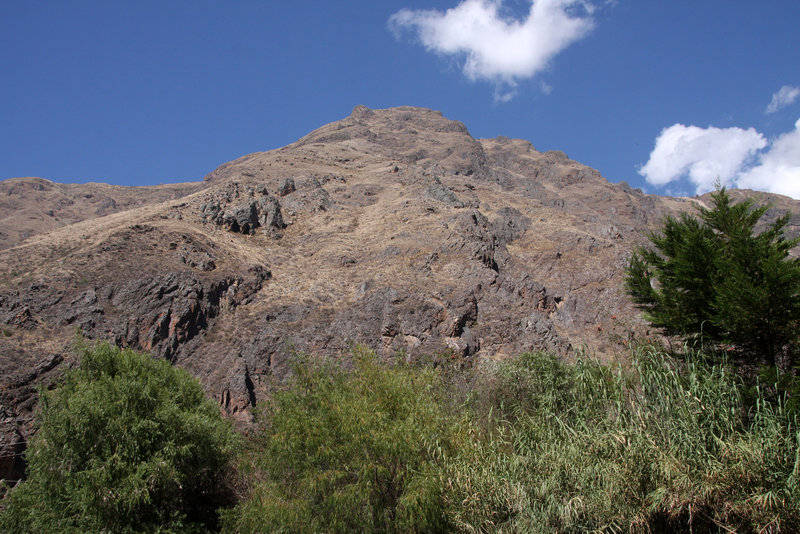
[0,344,237,532]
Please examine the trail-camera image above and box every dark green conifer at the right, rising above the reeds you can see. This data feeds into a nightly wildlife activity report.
[626,188,800,367]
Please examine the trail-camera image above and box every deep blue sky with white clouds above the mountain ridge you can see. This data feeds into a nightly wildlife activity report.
[0,0,800,198]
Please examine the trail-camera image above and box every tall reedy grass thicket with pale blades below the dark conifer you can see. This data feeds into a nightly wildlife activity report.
[440,347,800,533]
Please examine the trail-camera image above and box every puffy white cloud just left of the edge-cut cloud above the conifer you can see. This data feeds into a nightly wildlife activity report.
[639,124,767,193]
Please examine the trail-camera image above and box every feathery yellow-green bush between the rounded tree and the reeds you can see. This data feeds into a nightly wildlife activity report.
[223,348,451,533]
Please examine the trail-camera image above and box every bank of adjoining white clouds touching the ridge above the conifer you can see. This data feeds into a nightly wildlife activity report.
[639,120,800,199]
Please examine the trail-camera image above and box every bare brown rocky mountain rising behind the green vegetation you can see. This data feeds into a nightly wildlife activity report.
[0,106,800,479]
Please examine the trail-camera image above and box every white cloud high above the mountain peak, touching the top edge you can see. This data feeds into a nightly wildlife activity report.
[389,0,594,101]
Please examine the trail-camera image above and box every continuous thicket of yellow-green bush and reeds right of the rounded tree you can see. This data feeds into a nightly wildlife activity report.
[223,347,800,533]
